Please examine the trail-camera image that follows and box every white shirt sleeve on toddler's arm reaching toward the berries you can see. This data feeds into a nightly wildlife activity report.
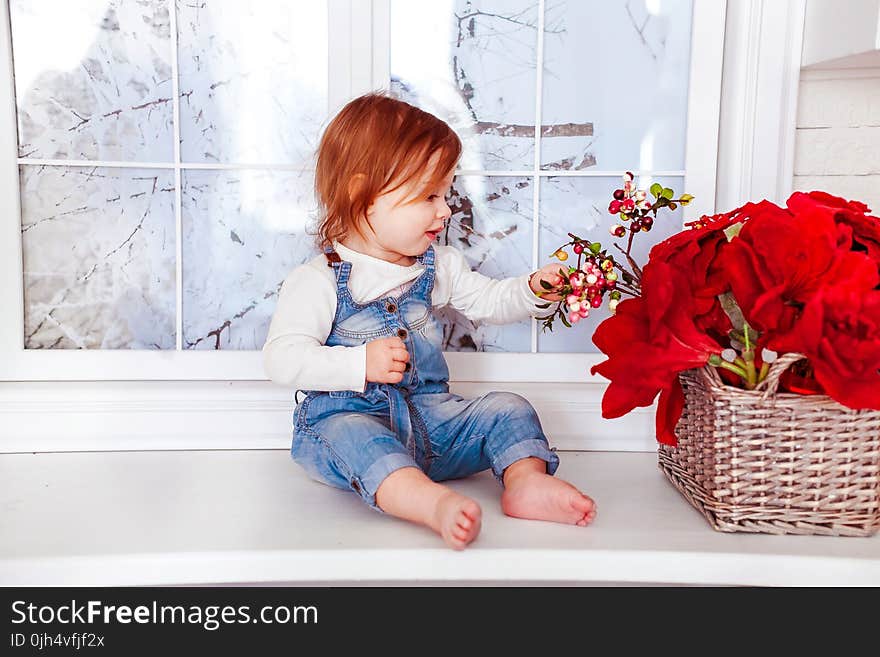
[432,246,546,324]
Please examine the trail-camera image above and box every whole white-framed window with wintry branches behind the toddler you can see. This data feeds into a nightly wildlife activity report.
[0,0,723,380]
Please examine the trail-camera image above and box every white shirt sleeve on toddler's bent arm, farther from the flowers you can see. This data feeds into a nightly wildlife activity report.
[262,264,367,392]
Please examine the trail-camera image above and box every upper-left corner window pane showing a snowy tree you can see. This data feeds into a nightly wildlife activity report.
[10,0,173,162]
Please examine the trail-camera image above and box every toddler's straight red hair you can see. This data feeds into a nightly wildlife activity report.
[315,92,461,248]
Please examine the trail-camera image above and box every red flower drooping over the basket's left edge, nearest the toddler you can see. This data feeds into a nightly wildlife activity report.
[590,261,721,445]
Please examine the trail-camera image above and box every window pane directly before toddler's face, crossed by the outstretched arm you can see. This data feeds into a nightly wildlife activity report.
[438,176,533,352]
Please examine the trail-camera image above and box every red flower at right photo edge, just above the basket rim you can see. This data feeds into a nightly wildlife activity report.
[768,286,880,410]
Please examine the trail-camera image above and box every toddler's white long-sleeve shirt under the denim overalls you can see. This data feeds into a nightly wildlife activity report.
[262,243,542,392]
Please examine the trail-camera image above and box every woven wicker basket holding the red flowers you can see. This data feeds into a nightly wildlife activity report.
[659,354,880,536]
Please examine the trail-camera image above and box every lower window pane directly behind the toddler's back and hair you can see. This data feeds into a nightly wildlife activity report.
[182,171,318,349]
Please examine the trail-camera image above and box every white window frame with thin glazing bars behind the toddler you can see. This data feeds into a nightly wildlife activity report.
[0,0,727,382]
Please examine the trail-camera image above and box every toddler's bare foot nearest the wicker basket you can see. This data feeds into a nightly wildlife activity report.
[501,464,596,527]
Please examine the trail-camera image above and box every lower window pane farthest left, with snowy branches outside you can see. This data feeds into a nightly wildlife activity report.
[21,166,176,349]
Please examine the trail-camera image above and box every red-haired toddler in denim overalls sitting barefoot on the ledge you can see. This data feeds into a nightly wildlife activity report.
[263,93,595,549]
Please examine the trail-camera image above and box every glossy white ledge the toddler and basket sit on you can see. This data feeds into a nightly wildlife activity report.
[0,450,880,586]
